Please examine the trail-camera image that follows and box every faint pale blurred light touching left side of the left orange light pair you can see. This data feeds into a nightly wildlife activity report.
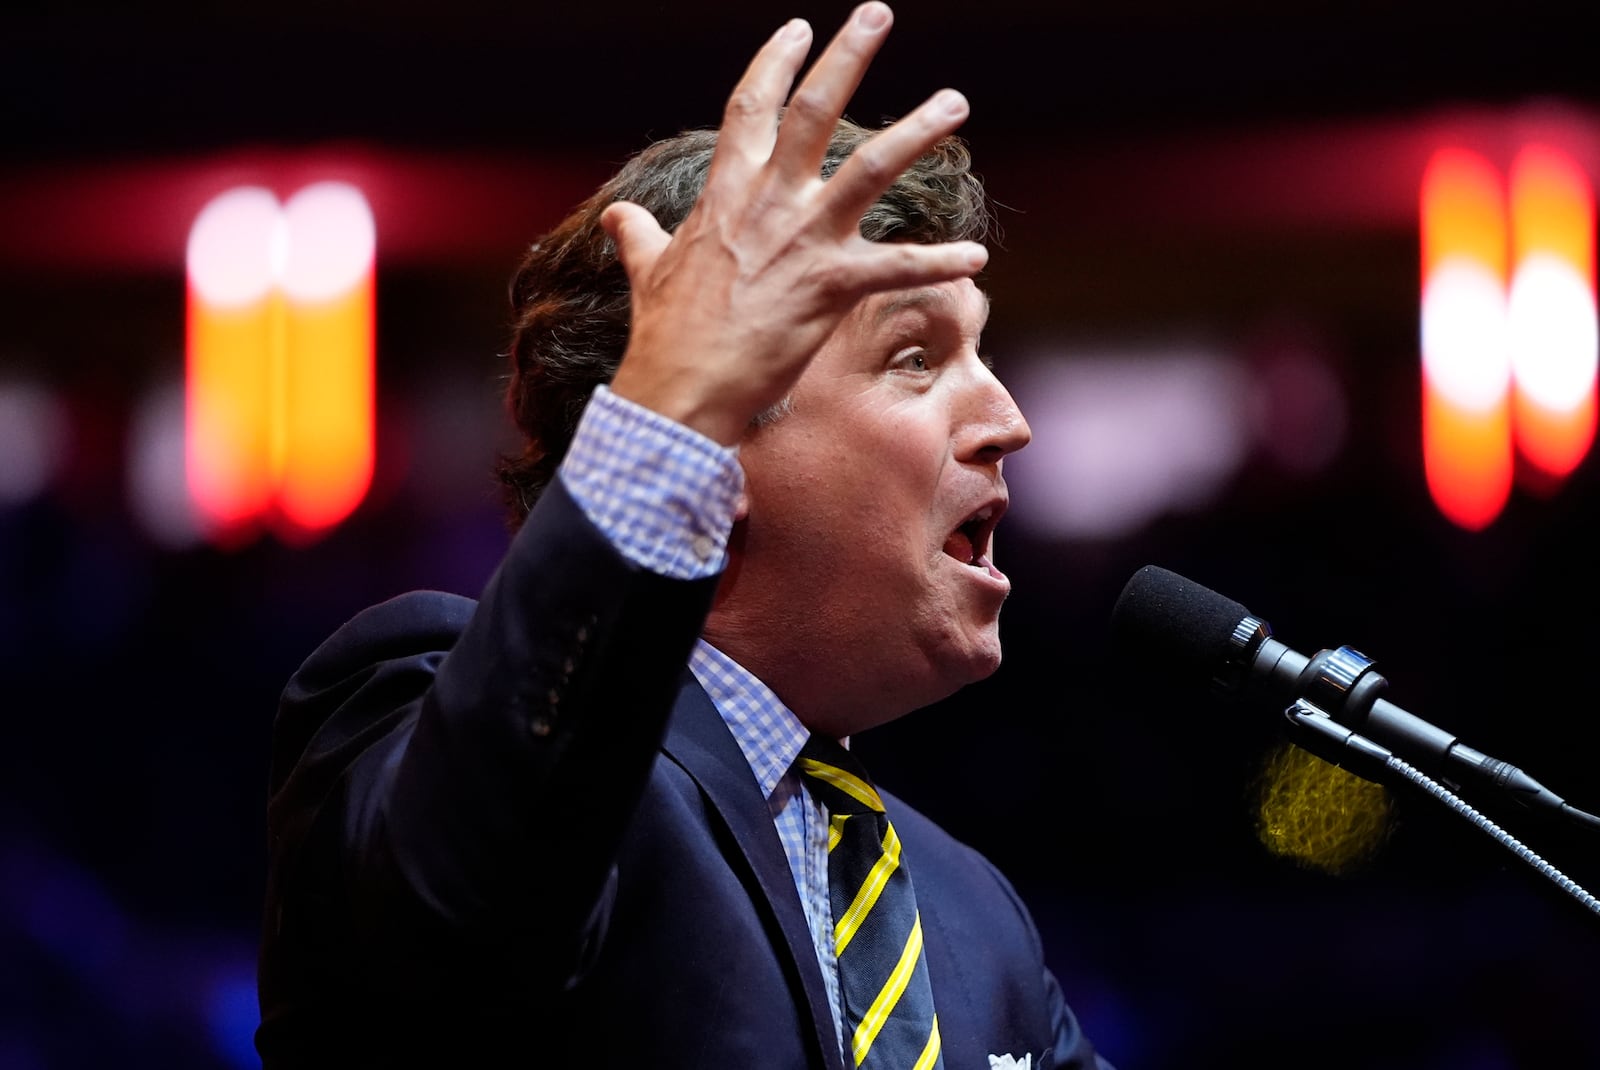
[126,382,206,550]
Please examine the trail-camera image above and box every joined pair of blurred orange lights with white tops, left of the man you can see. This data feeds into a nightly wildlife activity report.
[186,182,376,542]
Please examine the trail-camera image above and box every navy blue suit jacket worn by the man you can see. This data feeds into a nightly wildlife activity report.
[256,483,1101,1070]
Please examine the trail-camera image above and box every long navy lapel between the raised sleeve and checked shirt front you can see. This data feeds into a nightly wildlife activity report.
[662,673,845,1070]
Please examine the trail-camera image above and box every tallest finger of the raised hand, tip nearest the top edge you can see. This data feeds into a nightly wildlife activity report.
[771,0,894,181]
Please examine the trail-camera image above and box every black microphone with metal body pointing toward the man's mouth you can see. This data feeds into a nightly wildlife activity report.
[1110,565,1581,816]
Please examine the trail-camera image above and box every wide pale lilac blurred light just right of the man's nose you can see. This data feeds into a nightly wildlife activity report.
[1006,350,1250,539]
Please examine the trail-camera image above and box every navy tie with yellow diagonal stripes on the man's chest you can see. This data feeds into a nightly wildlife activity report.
[800,733,944,1070]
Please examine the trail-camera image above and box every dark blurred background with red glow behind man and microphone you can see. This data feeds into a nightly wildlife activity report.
[0,0,1600,1070]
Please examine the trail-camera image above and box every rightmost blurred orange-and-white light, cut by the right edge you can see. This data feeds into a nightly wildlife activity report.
[1509,146,1600,480]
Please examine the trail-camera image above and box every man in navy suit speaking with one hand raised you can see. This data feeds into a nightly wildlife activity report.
[258,0,1104,1070]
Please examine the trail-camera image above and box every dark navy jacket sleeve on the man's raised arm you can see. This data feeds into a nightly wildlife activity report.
[262,480,717,995]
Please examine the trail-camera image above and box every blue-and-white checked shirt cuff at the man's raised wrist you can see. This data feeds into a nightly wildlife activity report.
[560,385,744,579]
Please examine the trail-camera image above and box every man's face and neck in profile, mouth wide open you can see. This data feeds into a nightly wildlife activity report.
[706,280,1030,736]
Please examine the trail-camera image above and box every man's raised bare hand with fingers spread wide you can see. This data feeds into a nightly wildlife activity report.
[602,0,989,445]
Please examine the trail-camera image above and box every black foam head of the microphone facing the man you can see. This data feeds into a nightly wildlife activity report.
[1110,565,1270,688]
